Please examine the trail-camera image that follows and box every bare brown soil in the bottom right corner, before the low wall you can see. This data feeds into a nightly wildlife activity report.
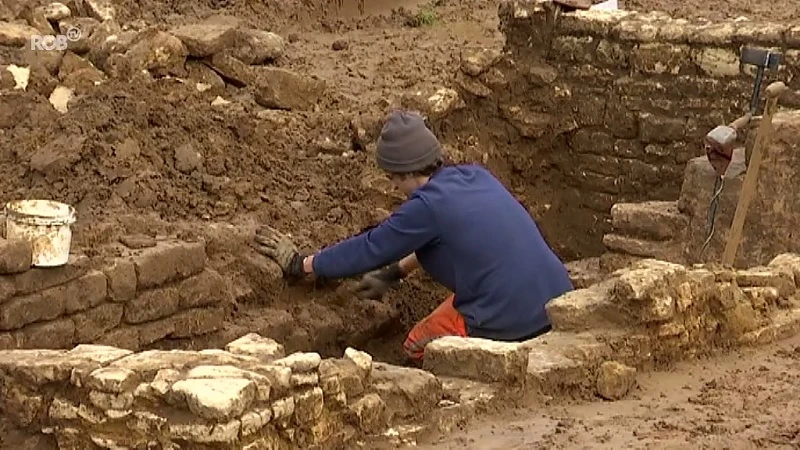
[418,337,800,450]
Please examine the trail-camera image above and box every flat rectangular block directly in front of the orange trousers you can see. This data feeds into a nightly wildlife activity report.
[423,336,528,383]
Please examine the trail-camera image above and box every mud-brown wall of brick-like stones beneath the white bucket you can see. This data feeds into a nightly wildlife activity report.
[0,239,233,350]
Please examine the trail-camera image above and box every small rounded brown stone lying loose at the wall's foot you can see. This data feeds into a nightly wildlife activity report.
[371,363,442,417]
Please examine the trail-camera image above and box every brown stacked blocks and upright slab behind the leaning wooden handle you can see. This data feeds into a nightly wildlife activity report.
[602,111,800,268]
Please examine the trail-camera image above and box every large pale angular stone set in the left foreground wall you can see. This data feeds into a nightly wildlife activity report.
[172,378,256,420]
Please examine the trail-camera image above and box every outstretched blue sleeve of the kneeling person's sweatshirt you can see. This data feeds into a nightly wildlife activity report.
[313,196,439,278]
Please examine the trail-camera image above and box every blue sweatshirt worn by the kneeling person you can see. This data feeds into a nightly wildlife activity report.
[313,165,573,340]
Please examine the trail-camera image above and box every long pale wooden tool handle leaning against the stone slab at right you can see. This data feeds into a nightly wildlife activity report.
[722,81,786,267]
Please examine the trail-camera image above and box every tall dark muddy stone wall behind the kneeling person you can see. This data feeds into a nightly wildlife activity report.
[441,0,800,259]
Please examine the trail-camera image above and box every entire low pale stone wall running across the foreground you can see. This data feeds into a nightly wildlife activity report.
[0,254,800,450]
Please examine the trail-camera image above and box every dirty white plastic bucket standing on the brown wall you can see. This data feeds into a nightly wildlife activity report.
[5,200,75,267]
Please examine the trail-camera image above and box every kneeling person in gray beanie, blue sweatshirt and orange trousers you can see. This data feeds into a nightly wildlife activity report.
[256,112,573,360]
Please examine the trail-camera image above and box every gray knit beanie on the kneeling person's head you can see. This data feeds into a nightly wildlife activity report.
[377,111,442,173]
